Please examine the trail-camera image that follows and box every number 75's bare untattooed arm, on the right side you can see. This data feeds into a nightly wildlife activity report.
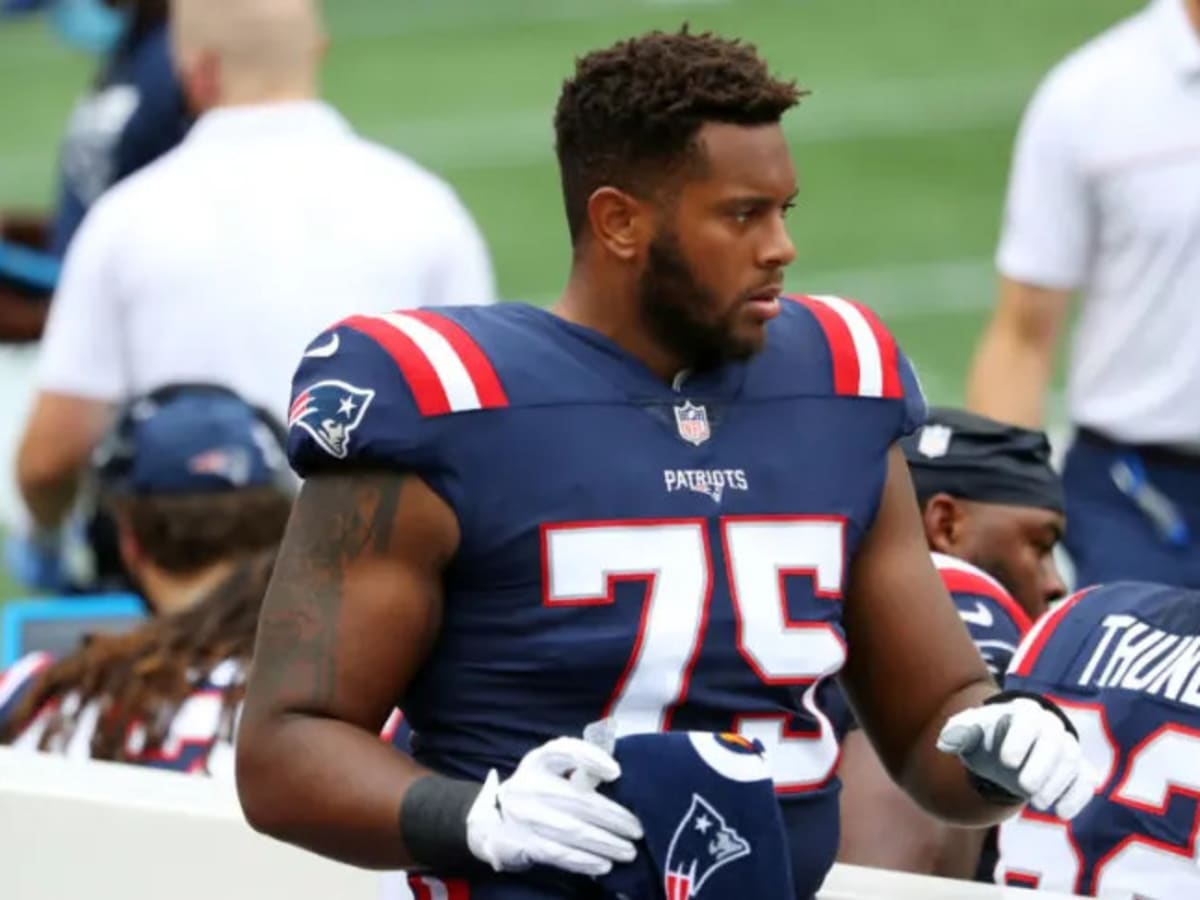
[842,448,1013,824]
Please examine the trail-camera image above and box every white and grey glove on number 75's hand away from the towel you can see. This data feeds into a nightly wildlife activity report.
[937,696,1099,820]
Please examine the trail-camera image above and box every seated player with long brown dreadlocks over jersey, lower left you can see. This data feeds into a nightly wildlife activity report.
[0,550,275,779]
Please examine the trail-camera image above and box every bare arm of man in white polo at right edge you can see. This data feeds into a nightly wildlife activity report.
[967,277,1072,428]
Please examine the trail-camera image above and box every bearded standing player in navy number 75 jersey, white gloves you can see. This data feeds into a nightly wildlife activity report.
[238,30,1092,898]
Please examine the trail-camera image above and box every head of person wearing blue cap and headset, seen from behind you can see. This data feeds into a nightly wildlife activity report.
[89,384,293,613]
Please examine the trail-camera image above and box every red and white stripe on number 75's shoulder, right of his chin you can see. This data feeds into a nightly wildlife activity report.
[786,295,904,398]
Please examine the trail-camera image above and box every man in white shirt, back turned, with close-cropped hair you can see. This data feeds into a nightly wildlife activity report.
[17,0,494,532]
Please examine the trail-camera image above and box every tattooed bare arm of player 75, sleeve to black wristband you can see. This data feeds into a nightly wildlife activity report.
[238,473,458,869]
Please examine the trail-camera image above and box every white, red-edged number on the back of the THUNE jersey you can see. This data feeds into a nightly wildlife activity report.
[997,700,1200,898]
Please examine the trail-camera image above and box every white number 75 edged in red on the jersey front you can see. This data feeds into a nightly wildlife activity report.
[544,516,846,792]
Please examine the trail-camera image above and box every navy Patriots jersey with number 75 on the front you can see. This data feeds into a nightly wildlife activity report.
[289,298,924,898]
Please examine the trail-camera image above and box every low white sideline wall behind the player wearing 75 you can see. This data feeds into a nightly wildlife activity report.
[0,748,1089,900]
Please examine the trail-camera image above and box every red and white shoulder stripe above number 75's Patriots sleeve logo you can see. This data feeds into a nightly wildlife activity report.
[338,310,509,415]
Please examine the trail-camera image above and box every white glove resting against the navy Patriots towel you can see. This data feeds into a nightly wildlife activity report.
[467,738,642,876]
